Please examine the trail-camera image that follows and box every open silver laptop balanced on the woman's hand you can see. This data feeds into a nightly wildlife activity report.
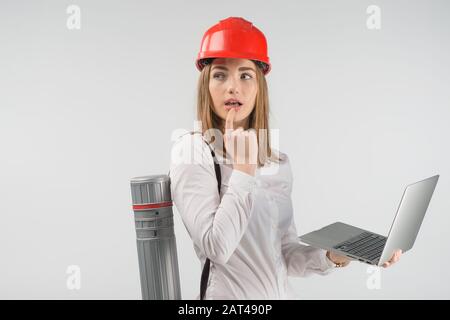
[299,175,439,266]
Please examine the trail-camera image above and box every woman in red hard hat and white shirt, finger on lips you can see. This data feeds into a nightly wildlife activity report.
[170,17,400,299]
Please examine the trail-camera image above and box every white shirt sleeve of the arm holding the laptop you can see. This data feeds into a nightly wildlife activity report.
[281,154,335,277]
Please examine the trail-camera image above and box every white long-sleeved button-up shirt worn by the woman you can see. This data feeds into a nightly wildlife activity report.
[169,134,334,299]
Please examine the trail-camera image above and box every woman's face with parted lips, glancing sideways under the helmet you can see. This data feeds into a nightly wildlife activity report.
[209,58,258,129]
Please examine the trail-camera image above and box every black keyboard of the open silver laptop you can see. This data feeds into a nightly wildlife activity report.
[333,231,386,261]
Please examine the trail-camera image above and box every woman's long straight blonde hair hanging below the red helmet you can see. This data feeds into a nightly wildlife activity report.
[197,59,280,167]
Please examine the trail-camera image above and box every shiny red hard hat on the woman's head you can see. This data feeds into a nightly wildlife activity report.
[196,17,271,74]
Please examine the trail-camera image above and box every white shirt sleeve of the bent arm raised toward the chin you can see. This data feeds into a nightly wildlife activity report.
[169,135,256,264]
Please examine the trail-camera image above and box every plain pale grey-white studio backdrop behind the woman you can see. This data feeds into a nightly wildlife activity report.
[0,0,450,299]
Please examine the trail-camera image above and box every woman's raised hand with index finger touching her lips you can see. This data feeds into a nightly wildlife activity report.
[224,108,258,176]
